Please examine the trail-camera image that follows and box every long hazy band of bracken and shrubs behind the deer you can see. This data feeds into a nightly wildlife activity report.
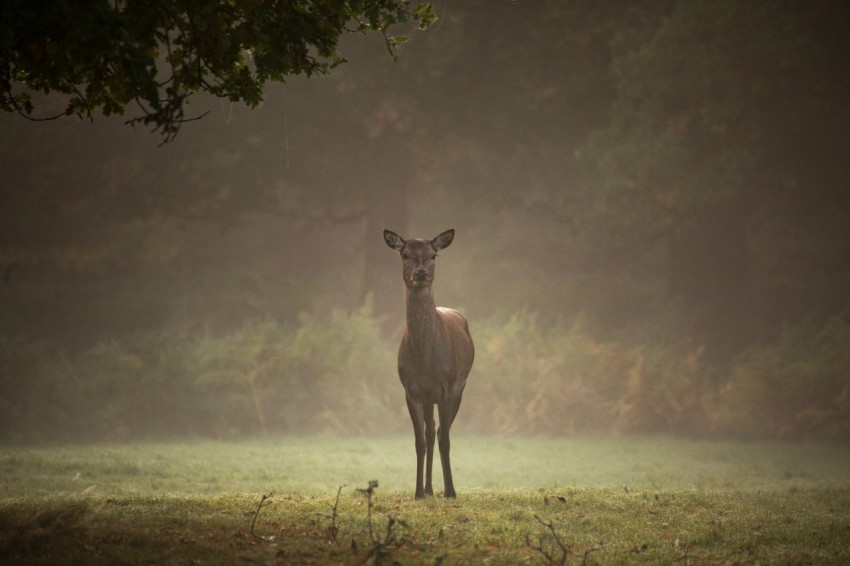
[0,301,850,442]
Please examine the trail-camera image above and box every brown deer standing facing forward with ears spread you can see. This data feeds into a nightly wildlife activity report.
[384,229,475,499]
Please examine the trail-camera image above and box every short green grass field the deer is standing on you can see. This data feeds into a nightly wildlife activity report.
[0,436,850,564]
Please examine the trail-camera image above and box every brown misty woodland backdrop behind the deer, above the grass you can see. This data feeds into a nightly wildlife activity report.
[0,0,850,442]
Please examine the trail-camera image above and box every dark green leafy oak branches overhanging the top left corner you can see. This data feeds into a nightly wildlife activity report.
[0,0,435,141]
